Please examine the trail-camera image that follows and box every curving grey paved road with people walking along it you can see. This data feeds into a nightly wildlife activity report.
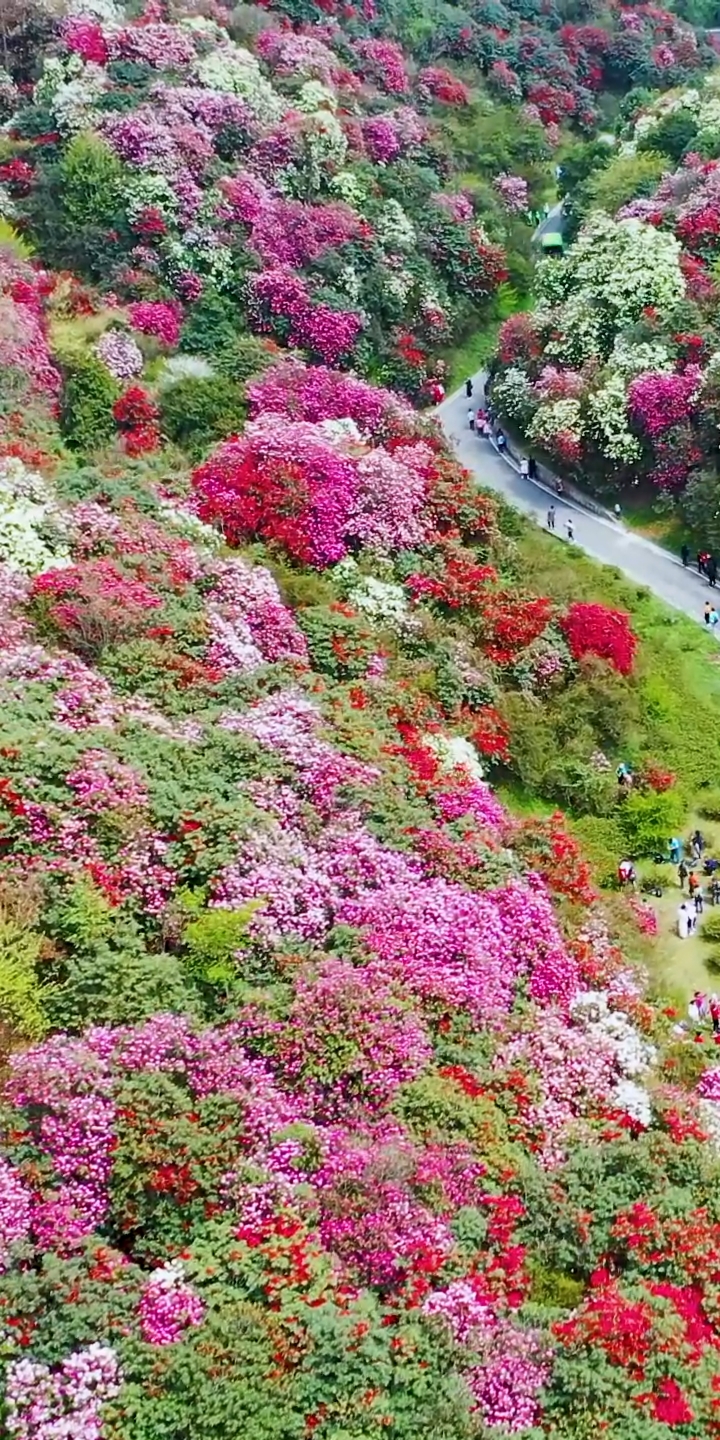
[436,374,720,629]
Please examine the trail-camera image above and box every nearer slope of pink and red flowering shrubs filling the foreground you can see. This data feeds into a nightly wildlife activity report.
[0,334,720,1440]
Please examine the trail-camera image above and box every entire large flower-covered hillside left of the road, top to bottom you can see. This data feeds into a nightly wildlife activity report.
[0,0,720,1440]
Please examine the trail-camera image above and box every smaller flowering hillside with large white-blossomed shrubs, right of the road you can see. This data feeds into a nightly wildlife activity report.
[495,67,720,549]
